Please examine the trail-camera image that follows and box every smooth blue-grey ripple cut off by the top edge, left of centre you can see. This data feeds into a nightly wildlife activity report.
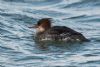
[3,0,63,6]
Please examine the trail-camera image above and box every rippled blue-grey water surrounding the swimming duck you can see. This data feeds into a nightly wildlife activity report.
[0,0,100,67]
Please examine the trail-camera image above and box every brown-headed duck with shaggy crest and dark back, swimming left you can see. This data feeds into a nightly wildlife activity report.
[29,18,88,42]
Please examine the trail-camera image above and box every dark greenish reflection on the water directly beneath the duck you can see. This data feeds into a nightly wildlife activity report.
[35,41,85,52]
